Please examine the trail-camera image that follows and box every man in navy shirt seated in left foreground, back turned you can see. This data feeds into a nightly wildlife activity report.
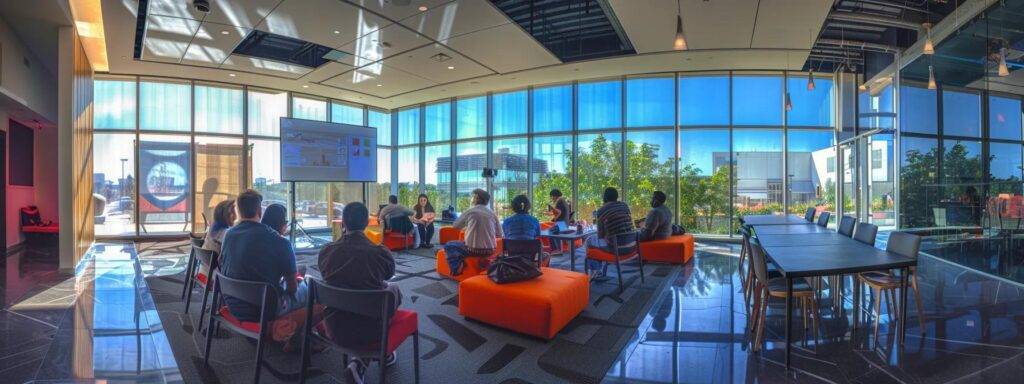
[220,189,308,350]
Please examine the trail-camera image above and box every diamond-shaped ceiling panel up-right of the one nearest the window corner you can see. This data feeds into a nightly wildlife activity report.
[384,44,494,83]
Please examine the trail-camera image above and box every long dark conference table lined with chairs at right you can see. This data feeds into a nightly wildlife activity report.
[743,216,918,370]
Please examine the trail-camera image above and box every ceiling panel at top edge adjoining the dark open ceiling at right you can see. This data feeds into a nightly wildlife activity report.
[751,0,831,49]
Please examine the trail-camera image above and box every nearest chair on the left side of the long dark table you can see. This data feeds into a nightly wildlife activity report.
[751,239,819,351]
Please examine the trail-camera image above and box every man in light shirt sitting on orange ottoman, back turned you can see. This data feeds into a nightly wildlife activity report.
[444,188,502,275]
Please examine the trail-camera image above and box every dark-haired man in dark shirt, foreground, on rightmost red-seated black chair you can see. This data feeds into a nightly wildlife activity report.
[317,202,401,383]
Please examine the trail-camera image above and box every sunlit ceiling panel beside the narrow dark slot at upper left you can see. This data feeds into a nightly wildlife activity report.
[142,15,200,62]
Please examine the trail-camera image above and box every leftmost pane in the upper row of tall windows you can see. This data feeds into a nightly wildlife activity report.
[92,80,135,129]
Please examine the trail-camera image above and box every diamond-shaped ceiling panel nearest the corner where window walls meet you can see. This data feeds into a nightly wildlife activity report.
[323,63,436,97]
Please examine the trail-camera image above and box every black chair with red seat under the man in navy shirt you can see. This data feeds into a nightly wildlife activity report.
[203,270,278,383]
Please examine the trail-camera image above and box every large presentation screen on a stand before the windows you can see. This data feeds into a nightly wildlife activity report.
[280,118,377,182]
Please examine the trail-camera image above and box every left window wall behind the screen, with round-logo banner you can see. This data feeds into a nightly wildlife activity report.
[93,77,391,239]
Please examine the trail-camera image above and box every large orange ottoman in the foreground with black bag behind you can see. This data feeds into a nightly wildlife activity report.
[459,268,590,339]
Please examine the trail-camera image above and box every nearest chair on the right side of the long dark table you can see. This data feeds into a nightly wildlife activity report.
[854,232,925,341]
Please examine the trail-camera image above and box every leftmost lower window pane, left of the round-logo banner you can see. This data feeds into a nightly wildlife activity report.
[92,133,135,236]
